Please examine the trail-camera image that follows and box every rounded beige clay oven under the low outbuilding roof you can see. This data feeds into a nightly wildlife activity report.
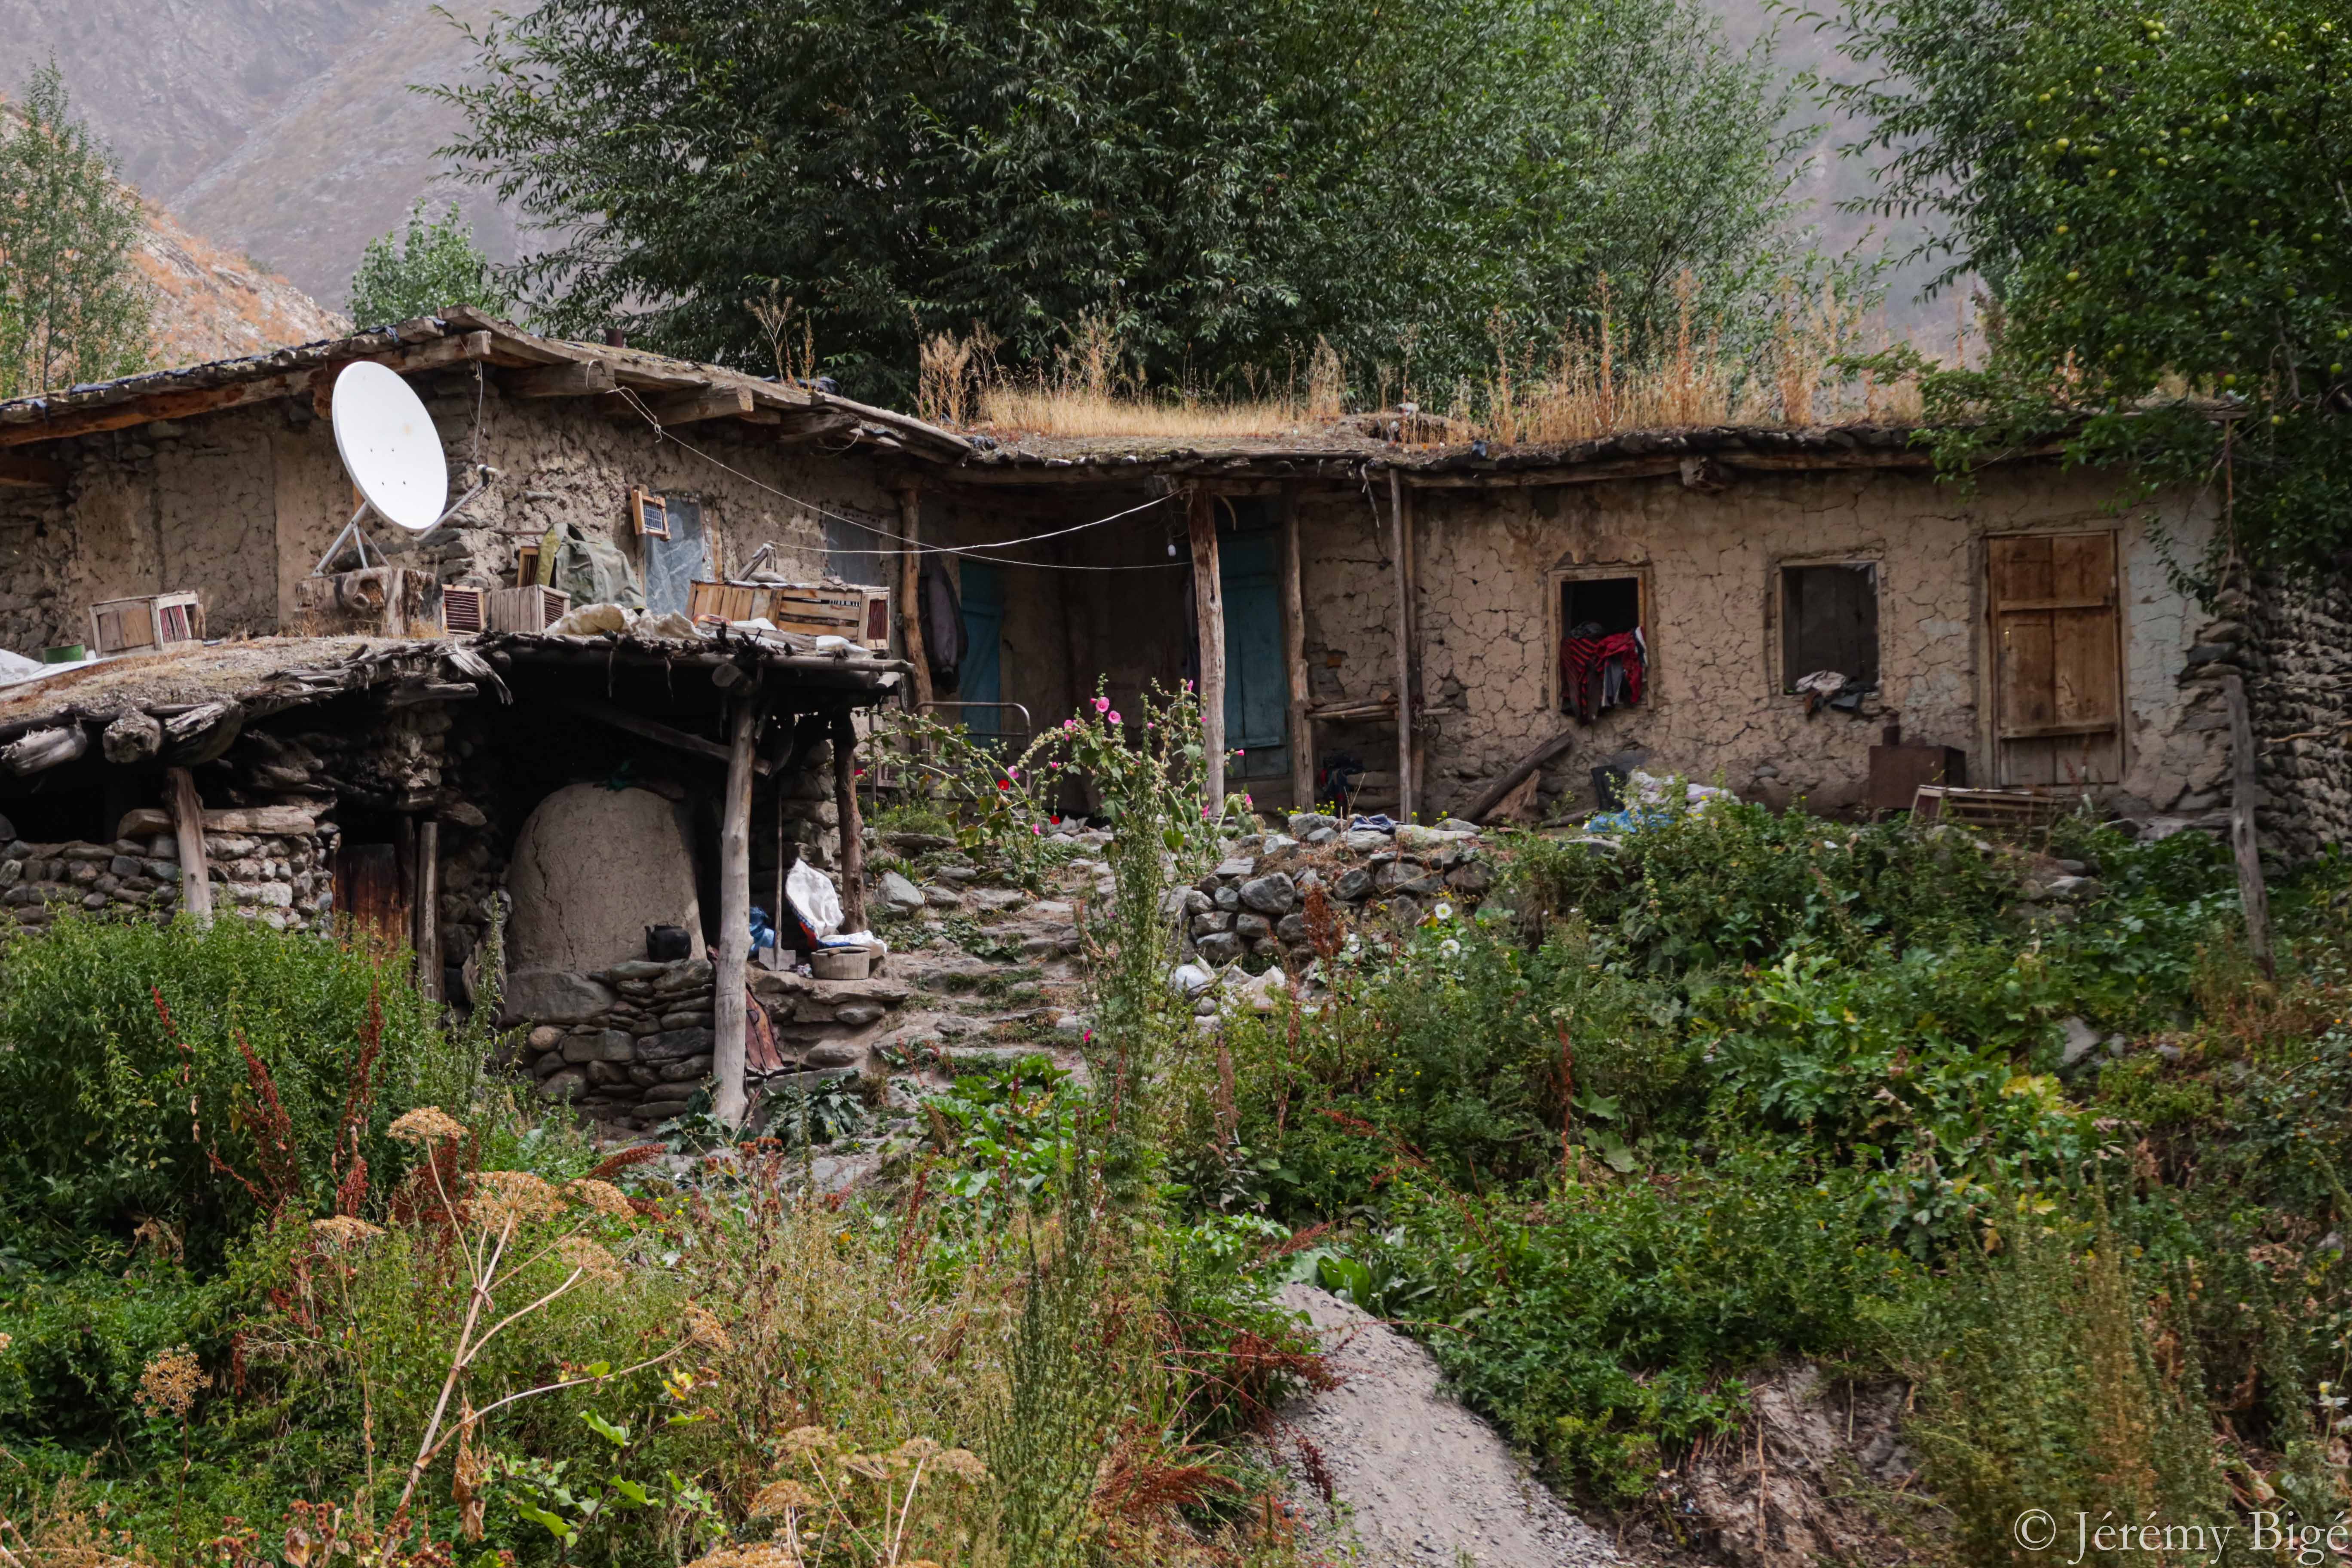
[505,785,703,973]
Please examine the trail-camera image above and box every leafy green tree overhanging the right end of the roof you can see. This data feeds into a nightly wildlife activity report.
[1834,0,2352,569]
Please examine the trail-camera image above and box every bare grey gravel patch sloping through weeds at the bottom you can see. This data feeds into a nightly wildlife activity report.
[1275,1286,1620,1568]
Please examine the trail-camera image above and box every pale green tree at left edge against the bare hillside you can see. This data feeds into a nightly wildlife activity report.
[0,64,153,397]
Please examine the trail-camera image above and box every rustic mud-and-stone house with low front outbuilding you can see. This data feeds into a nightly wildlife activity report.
[0,310,2352,1121]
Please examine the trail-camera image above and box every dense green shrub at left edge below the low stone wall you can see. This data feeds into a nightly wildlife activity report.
[0,915,473,1267]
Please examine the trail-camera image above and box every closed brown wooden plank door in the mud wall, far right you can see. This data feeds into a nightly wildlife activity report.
[1985,534,2124,790]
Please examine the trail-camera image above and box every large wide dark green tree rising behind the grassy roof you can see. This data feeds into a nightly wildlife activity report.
[442,0,1792,392]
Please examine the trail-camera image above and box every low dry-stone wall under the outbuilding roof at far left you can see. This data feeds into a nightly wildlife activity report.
[0,825,334,931]
